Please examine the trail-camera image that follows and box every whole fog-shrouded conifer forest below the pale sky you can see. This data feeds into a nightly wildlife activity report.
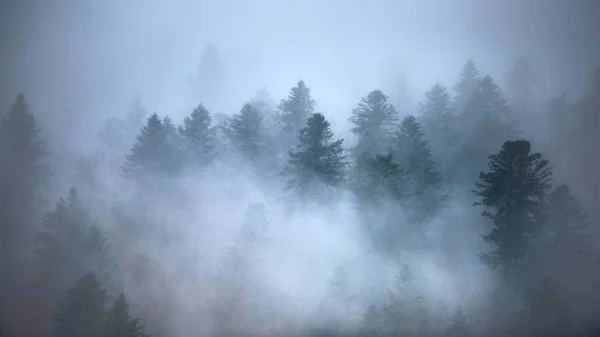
[0,48,600,337]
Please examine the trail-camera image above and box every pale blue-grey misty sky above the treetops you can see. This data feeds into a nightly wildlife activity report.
[0,0,600,150]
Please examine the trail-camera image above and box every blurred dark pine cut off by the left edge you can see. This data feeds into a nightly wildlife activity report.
[0,95,50,331]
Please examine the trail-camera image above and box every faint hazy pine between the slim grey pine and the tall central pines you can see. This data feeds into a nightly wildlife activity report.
[223,103,267,162]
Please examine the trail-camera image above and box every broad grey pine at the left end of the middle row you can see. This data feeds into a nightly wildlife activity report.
[123,113,175,182]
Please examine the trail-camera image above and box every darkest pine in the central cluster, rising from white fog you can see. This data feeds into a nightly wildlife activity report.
[282,113,346,203]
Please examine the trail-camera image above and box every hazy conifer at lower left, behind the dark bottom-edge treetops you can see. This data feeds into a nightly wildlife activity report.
[34,187,118,306]
